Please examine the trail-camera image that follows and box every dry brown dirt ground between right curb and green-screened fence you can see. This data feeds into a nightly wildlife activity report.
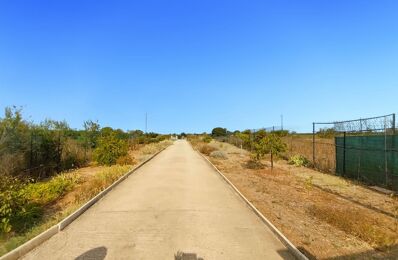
[196,141,398,259]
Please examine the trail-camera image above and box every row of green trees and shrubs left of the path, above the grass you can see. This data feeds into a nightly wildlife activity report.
[0,107,167,179]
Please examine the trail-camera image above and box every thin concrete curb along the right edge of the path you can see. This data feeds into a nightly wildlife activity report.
[196,149,308,260]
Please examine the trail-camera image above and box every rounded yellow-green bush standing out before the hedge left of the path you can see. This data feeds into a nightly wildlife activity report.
[94,132,128,165]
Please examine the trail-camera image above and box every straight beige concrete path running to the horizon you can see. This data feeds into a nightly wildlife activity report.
[25,141,291,260]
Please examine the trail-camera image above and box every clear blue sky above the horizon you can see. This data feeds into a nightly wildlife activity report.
[0,0,398,133]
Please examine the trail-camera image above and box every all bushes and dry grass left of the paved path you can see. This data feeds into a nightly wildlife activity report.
[0,107,171,255]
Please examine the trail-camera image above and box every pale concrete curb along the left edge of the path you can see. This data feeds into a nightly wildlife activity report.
[0,145,171,260]
